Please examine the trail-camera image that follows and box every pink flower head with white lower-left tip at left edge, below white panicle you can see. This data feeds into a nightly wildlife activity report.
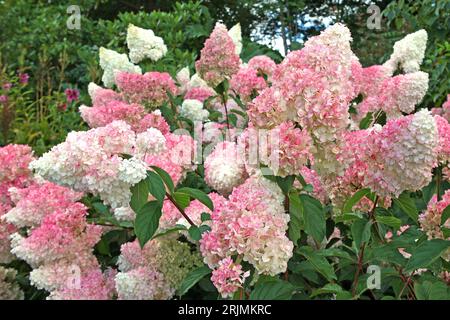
[2,182,82,228]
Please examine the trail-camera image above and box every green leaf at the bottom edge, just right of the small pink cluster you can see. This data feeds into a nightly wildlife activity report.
[250,279,295,300]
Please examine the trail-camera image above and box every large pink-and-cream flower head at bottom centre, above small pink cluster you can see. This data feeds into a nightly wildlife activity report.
[200,177,293,275]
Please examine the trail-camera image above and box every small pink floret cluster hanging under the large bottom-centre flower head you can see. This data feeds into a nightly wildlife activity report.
[211,257,250,298]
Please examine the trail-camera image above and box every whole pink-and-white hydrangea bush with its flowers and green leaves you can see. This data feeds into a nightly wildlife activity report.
[0,23,450,299]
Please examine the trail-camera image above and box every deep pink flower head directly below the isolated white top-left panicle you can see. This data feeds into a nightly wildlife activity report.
[115,71,177,109]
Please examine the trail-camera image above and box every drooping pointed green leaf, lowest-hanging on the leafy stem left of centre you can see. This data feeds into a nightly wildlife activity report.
[134,201,162,247]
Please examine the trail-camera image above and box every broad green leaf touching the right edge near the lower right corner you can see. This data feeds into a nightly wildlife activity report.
[405,239,450,272]
